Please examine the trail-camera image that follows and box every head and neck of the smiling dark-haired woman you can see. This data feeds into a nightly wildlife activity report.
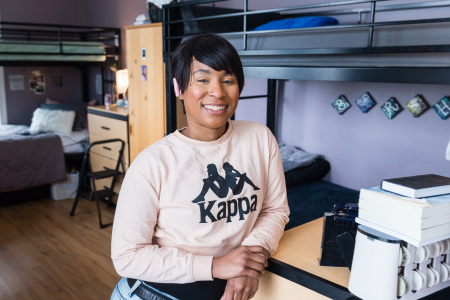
[170,34,244,141]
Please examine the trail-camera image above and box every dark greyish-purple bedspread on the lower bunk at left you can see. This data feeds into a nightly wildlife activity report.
[0,125,66,192]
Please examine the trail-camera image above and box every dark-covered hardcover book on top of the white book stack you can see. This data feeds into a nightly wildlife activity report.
[380,174,450,198]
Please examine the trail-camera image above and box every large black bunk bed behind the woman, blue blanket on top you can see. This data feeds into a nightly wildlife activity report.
[163,0,450,299]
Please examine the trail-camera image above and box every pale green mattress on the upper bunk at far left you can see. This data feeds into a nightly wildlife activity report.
[0,40,106,62]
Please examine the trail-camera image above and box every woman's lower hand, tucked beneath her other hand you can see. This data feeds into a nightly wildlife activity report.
[220,276,259,300]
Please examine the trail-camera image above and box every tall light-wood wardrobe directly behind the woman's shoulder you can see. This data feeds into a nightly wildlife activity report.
[125,23,187,162]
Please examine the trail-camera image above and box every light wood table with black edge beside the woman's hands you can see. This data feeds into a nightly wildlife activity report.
[253,218,352,300]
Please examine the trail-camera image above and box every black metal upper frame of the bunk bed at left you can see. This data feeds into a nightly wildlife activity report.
[0,22,121,101]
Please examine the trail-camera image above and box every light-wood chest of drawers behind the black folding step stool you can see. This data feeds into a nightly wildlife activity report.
[88,105,130,193]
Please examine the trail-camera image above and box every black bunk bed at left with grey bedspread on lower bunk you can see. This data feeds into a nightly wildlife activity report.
[0,22,121,205]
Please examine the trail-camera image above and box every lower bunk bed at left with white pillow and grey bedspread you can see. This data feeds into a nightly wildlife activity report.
[0,99,89,192]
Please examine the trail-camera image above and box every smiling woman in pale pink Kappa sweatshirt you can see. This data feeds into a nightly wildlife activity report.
[111,34,289,300]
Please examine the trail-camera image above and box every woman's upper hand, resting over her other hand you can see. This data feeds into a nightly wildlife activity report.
[212,246,268,279]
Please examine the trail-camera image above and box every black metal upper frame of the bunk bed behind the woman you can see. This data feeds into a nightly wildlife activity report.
[163,0,450,133]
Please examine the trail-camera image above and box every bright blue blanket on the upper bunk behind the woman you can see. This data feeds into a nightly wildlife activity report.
[254,17,339,31]
